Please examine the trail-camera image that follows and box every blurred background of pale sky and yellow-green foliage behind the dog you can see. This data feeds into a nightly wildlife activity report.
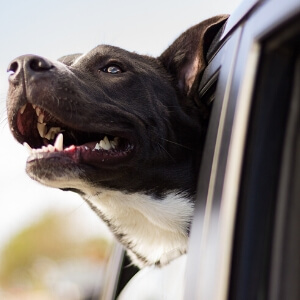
[0,0,241,300]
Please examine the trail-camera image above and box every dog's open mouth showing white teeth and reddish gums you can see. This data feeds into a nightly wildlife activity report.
[16,103,134,165]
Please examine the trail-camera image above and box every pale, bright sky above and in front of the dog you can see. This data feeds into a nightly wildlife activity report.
[0,0,241,250]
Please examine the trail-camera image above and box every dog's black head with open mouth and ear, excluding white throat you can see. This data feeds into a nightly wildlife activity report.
[7,16,226,199]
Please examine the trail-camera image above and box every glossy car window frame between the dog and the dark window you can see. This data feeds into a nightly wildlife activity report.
[185,0,299,300]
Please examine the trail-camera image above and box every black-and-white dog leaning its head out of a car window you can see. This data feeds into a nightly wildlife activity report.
[7,15,228,268]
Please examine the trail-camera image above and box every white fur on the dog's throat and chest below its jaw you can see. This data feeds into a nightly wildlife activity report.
[84,189,193,267]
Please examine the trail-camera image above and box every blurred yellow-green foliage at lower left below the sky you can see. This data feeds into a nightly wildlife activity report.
[0,213,109,286]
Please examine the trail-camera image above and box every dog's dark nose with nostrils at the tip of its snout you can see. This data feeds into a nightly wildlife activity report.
[7,55,53,81]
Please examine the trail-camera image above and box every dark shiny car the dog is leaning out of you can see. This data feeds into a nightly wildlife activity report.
[102,0,300,300]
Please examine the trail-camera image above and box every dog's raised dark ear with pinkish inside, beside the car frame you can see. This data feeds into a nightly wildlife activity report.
[158,15,228,96]
